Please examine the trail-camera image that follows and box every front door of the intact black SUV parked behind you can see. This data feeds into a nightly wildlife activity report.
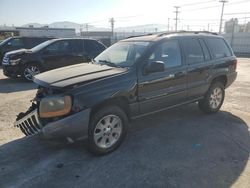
[41,40,70,70]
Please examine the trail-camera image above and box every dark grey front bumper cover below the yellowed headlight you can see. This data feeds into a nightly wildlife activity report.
[42,109,90,139]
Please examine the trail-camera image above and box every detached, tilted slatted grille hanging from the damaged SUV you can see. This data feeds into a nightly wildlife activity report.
[14,109,43,136]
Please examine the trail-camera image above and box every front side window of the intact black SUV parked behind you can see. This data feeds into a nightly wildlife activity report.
[46,41,71,53]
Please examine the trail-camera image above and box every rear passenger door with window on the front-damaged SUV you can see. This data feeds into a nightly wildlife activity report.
[181,38,213,100]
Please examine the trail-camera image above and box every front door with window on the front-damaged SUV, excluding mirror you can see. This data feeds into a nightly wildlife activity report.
[138,40,187,114]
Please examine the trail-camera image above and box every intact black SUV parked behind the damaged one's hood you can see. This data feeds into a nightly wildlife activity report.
[2,38,106,81]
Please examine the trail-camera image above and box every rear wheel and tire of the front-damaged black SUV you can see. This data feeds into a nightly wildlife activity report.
[198,82,225,114]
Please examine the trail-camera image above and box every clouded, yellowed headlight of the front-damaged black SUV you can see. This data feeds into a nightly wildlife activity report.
[39,96,72,118]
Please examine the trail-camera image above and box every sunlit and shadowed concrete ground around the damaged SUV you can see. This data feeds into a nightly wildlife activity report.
[0,58,250,188]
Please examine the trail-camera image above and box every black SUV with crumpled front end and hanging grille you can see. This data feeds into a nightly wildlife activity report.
[15,32,237,154]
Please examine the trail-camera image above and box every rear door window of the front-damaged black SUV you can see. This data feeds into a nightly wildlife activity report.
[182,38,204,64]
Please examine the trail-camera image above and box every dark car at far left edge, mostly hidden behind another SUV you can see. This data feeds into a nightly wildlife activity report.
[0,37,52,62]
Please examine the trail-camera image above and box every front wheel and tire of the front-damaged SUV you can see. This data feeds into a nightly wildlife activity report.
[88,106,128,155]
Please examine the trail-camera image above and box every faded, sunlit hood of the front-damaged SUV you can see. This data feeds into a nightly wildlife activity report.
[33,63,127,89]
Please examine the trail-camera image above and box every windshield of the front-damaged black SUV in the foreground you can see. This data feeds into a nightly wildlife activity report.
[94,42,149,67]
